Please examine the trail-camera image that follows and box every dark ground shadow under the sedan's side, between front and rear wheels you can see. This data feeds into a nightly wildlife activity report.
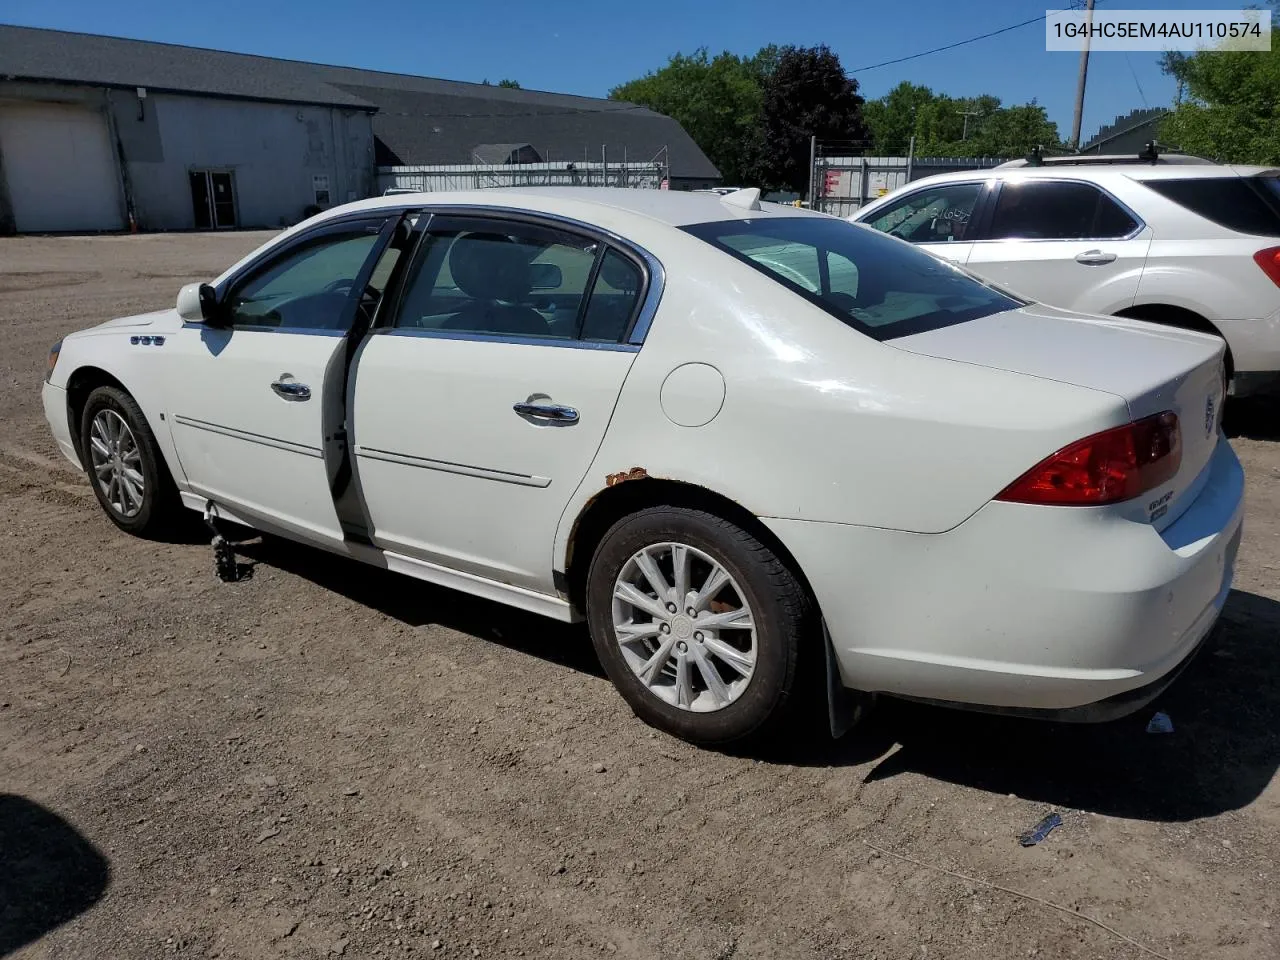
[236,536,604,678]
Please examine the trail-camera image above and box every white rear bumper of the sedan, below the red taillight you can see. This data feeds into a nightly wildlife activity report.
[765,442,1244,719]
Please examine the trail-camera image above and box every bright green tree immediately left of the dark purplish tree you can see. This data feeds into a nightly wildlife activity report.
[609,47,772,183]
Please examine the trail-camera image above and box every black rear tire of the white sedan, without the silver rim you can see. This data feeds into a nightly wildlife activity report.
[586,507,815,745]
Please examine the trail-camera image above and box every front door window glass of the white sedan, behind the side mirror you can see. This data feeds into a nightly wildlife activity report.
[227,227,378,330]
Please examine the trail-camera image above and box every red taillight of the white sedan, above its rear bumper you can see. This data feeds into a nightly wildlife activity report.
[996,411,1183,507]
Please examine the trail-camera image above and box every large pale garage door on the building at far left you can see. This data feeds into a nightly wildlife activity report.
[0,102,124,233]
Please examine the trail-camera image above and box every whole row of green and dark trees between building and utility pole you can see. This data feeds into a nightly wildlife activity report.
[609,46,1060,193]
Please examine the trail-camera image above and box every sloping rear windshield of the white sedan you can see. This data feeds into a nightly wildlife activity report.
[682,216,1025,340]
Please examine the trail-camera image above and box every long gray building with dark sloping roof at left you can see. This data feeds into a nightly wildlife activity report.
[0,26,719,233]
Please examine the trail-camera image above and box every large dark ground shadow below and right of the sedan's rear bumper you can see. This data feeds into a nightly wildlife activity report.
[780,591,1280,822]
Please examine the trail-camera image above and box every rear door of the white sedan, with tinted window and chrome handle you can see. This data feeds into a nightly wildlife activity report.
[351,216,657,594]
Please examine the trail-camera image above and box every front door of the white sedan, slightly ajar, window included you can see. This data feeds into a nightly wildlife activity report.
[165,214,398,544]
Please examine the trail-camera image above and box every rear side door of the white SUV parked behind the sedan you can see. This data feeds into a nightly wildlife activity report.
[968,178,1151,314]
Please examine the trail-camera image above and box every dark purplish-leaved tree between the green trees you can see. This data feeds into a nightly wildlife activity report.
[759,46,867,192]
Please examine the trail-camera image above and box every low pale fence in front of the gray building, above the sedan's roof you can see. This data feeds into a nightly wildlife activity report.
[378,160,667,193]
